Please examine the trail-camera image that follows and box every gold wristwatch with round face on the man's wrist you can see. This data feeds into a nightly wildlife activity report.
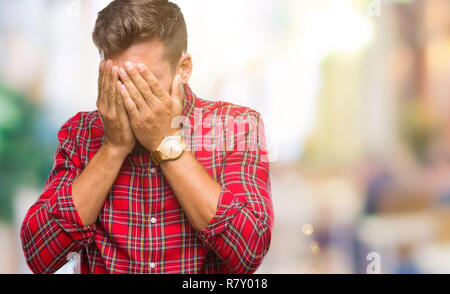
[150,136,186,166]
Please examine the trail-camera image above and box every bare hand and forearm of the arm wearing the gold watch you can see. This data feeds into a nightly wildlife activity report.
[120,62,222,231]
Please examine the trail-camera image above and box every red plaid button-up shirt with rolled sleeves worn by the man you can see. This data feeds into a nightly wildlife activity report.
[21,85,273,273]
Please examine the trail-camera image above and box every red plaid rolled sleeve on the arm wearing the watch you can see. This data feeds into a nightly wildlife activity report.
[198,112,274,274]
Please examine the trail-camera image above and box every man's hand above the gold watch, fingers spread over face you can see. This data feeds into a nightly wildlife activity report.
[119,62,184,151]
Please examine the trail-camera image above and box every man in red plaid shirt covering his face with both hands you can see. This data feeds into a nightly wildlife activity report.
[21,0,273,273]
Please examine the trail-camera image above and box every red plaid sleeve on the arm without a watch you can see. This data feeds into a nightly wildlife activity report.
[21,114,95,273]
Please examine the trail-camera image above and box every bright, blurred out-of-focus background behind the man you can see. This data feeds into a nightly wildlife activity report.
[0,0,450,273]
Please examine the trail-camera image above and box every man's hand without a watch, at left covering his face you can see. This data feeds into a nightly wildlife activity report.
[97,60,135,156]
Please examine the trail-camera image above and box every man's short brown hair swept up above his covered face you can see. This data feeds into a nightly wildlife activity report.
[92,0,187,70]
